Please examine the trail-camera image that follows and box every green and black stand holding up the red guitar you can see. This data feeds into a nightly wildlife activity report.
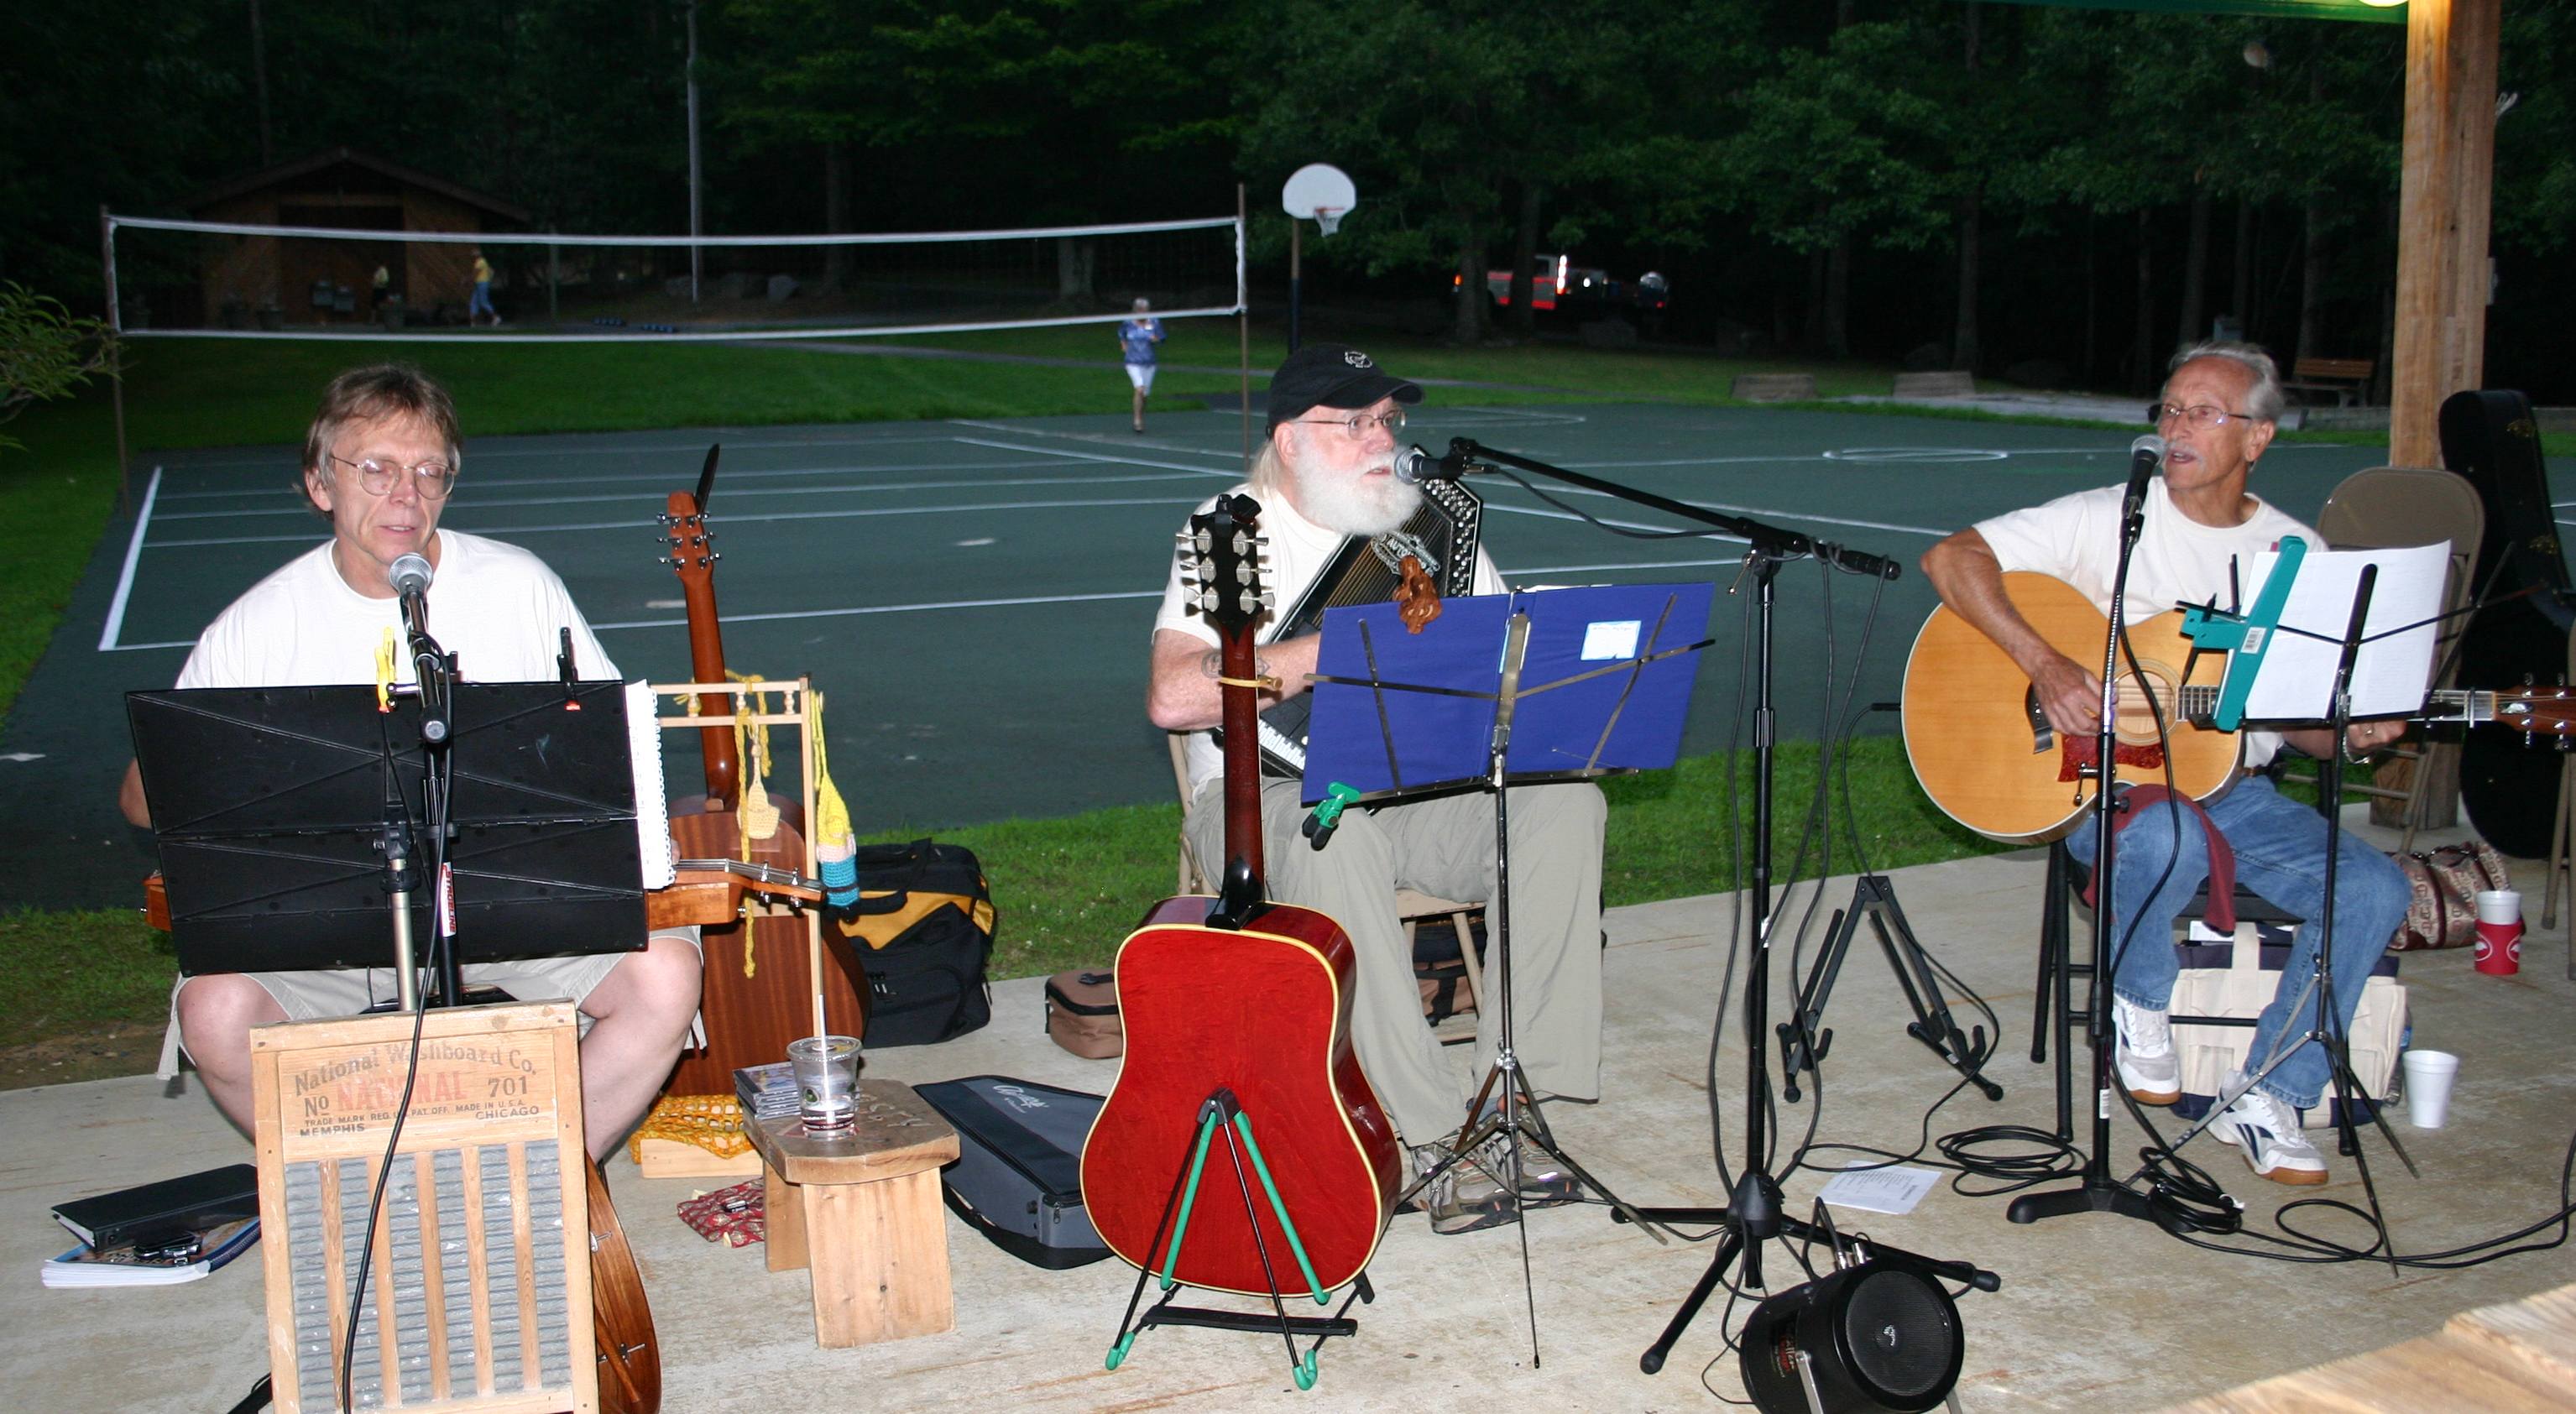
[1105,1087,1378,1388]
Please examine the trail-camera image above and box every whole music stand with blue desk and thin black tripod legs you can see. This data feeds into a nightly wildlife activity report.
[1304,585,1716,1365]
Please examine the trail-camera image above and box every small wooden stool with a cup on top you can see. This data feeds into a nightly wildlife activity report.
[745,1079,959,1349]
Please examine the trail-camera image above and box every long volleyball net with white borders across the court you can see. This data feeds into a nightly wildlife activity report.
[103,209,1246,342]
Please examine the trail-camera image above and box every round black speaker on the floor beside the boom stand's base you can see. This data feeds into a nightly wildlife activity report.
[1739,1262,1968,1414]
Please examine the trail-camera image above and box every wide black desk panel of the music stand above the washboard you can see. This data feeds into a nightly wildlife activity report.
[126,680,646,1002]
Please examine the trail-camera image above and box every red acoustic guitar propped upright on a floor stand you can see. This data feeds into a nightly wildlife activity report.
[1082,497,1398,1296]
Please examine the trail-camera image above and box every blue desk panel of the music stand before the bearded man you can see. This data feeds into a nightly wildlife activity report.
[1301,582,1716,804]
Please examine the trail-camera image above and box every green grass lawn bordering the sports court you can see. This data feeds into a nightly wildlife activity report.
[0,320,2349,1084]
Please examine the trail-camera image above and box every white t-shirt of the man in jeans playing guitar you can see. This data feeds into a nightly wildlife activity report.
[1976,477,2326,768]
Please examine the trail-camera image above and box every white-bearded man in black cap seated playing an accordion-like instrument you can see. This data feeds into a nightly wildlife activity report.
[1147,342,1607,1234]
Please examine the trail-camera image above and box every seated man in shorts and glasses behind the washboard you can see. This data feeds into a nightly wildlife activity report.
[118,363,698,1156]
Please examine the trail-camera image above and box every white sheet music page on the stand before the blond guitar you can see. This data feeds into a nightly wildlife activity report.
[2229,544,2450,721]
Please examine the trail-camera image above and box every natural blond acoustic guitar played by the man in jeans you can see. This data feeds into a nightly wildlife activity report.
[1904,569,2576,845]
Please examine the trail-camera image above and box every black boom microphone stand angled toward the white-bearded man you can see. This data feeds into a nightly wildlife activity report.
[1448,438,2002,1375]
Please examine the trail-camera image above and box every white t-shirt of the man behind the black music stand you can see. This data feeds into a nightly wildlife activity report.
[178,530,619,687]
